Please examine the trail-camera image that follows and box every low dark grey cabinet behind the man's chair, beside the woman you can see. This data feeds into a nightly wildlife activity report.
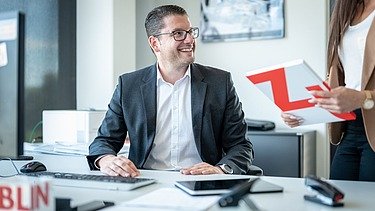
[247,129,316,177]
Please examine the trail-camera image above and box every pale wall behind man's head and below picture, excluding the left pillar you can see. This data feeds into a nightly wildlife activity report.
[136,0,329,177]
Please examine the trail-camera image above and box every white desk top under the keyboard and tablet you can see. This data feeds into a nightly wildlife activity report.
[0,154,375,211]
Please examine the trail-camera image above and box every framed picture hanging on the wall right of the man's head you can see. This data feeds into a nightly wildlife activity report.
[200,0,284,42]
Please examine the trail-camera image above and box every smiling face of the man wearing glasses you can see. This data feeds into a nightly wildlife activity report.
[155,15,195,68]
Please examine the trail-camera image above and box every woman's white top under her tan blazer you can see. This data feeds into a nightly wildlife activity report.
[339,10,375,91]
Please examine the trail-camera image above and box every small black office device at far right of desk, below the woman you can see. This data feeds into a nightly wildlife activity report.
[304,176,344,207]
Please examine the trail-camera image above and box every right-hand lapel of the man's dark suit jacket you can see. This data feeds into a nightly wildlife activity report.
[191,64,207,155]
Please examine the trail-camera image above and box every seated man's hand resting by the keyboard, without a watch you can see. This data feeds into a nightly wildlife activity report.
[98,155,140,177]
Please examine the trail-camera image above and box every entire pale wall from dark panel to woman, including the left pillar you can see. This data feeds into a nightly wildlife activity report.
[77,0,329,177]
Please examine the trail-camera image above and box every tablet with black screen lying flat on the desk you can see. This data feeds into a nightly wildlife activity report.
[175,179,283,196]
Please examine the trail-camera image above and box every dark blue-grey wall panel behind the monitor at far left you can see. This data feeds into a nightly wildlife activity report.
[0,0,76,142]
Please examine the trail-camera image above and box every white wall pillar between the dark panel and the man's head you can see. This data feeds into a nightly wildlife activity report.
[77,0,136,109]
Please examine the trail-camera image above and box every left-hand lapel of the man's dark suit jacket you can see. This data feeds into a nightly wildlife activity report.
[141,65,156,162]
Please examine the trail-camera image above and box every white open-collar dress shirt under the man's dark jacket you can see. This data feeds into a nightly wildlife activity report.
[144,66,202,170]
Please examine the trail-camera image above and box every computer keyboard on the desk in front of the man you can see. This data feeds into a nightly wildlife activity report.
[22,171,156,191]
